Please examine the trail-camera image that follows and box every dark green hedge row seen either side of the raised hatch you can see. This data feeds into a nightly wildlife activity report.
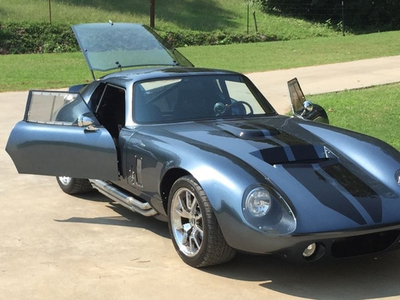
[0,23,277,54]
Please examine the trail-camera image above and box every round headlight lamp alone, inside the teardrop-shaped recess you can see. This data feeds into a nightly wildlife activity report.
[245,187,271,218]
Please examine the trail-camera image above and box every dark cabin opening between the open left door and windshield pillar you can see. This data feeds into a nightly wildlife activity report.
[95,85,125,138]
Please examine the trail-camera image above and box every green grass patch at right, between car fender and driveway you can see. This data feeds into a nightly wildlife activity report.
[309,84,400,151]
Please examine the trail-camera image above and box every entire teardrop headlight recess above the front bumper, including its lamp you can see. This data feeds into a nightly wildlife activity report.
[242,185,297,235]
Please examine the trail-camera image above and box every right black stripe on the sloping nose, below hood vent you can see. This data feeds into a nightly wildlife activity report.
[322,164,383,223]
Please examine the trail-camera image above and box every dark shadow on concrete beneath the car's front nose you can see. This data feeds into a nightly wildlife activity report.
[203,251,400,300]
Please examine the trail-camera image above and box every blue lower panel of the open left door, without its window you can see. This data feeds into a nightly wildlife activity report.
[6,121,118,180]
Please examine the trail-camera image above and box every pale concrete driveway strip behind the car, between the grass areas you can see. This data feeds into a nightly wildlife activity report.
[248,56,400,114]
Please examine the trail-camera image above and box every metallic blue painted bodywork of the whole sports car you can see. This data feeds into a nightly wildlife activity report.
[7,62,400,253]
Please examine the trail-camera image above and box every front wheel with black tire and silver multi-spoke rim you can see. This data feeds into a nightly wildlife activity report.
[168,176,235,268]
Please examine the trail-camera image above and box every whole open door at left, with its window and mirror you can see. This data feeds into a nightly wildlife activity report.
[6,91,118,180]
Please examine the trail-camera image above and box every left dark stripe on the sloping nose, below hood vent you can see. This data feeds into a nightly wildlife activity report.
[284,165,366,225]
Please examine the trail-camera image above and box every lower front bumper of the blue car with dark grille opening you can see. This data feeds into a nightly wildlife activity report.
[223,214,400,261]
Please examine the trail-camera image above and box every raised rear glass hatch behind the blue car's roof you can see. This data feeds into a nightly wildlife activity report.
[72,21,193,78]
